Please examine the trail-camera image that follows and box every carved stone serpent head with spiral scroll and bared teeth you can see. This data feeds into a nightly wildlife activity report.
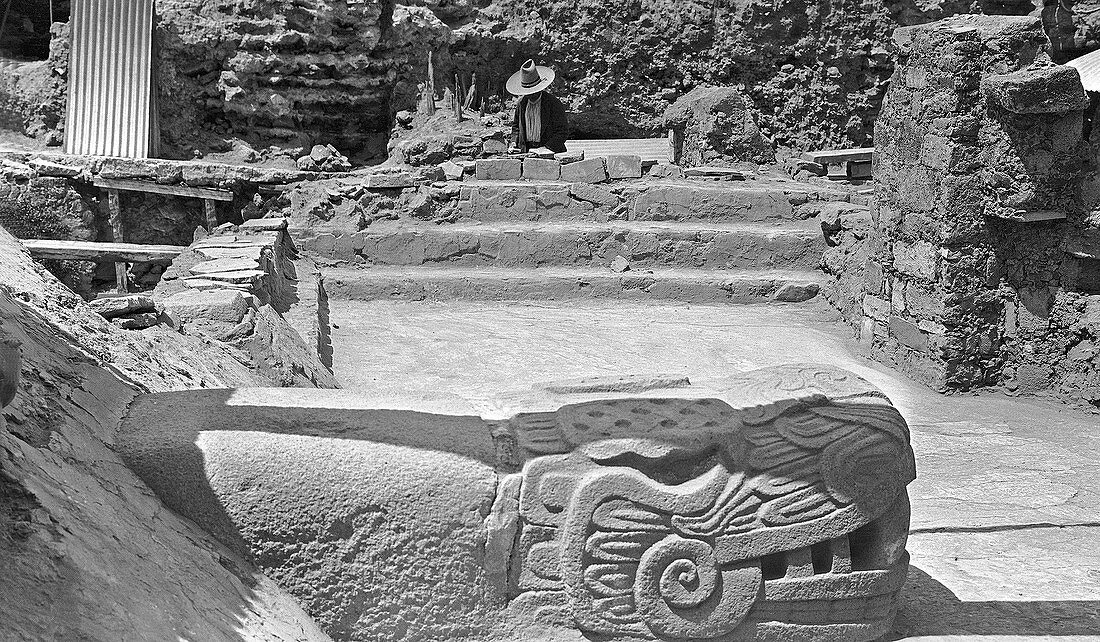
[506,362,914,640]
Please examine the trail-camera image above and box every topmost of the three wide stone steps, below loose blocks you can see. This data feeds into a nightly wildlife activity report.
[450,180,849,222]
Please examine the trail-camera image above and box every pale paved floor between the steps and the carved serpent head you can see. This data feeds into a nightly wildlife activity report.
[331,301,1100,642]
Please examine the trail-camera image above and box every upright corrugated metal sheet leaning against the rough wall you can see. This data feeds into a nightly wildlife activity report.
[65,0,154,158]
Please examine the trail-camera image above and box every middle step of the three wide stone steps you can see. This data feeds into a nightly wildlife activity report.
[300,221,825,269]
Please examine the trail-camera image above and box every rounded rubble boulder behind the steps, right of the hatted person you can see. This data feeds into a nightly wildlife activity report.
[662,87,776,167]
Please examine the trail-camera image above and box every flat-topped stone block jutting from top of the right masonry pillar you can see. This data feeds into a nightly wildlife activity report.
[981,65,1089,114]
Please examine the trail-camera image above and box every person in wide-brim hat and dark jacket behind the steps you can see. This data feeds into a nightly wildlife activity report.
[505,59,569,152]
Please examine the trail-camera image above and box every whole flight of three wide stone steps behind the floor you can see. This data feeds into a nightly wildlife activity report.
[303,174,849,303]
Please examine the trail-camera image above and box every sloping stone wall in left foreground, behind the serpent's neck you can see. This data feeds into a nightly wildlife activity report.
[0,223,329,642]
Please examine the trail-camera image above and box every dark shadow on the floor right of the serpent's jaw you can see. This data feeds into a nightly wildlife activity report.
[882,565,1100,642]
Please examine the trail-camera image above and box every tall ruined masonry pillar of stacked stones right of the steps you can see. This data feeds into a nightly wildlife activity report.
[861,15,1086,389]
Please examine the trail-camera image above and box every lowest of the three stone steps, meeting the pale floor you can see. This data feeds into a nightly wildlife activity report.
[325,266,825,303]
